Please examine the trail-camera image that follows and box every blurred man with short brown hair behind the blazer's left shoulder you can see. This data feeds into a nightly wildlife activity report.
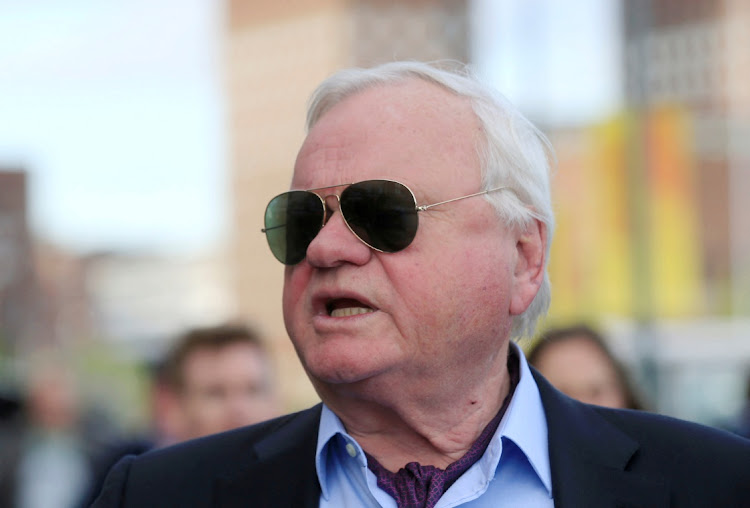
[83,325,281,506]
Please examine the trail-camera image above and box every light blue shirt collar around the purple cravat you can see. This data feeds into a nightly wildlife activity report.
[315,342,552,500]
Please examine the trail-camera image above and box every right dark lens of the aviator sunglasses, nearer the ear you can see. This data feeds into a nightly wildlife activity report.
[341,180,418,252]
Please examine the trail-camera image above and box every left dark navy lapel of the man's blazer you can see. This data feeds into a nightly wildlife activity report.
[215,404,321,508]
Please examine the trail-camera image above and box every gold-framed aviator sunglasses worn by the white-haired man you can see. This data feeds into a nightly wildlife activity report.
[261,180,507,265]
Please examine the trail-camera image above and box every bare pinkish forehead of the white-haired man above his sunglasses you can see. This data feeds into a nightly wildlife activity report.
[292,78,481,189]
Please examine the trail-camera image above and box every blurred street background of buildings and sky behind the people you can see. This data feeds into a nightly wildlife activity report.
[0,0,750,440]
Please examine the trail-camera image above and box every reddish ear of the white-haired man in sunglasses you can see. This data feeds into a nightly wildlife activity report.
[510,219,547,316]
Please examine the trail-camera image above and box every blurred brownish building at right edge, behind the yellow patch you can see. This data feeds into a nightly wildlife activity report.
[622,0,750,316]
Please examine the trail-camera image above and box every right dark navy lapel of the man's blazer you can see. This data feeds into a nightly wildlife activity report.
[532,368,669,508]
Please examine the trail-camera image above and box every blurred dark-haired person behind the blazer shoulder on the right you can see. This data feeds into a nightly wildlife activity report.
[526,324,644,409]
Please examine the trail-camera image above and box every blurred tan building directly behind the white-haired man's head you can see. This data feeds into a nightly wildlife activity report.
[227,0,469,408]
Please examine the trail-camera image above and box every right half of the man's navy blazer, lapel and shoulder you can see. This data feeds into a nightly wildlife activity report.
[532,369,750,506]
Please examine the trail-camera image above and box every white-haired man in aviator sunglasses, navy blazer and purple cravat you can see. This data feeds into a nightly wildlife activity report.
[97,63,750,507]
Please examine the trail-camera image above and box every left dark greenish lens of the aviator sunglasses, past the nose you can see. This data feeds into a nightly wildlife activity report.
[265,191,325,265]
